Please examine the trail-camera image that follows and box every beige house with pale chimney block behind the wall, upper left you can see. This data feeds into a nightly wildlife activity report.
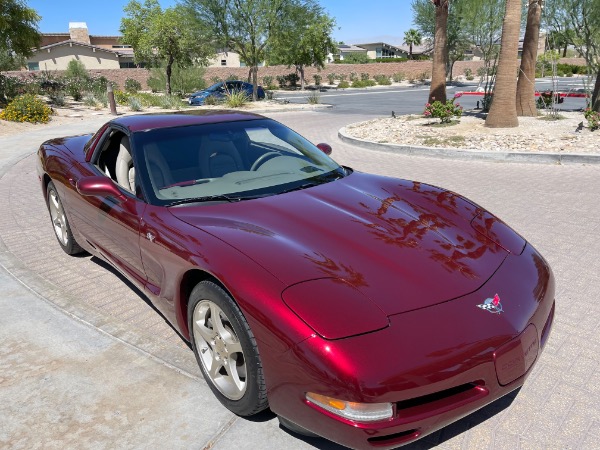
[27,22,136,70]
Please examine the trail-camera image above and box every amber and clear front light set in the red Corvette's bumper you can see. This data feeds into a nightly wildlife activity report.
[306,392,394,422]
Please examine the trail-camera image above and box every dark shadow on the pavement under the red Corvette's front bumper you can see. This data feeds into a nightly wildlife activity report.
[274,388,521,450]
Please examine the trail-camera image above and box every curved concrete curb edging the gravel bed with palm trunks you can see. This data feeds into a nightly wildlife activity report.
[338,127,600,165]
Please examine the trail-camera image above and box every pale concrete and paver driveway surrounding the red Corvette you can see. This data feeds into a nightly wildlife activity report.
[0,112,600,450]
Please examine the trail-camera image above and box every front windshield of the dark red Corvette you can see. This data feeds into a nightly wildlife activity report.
[133,119,346,206]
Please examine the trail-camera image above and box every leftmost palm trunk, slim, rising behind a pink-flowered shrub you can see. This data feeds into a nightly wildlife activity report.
[429,0,449,103]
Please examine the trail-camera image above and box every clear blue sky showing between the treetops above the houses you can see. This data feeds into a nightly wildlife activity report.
[25,0,412,45]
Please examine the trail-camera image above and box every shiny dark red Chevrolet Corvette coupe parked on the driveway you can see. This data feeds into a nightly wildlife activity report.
[37,111,554,449]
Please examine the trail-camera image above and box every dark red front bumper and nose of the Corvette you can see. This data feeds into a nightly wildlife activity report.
[268,245,554,449]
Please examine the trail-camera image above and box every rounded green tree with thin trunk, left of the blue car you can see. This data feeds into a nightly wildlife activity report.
[121,0,215,94]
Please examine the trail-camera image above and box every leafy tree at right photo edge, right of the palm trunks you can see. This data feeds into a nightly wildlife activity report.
[545,0,600,112]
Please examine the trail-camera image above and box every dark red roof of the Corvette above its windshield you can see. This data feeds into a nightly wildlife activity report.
[111,110,265,132]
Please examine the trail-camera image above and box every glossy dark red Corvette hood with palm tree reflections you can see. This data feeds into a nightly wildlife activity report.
[170,172,516,315]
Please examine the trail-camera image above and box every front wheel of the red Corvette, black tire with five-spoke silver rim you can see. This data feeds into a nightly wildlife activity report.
[188,281,269,416]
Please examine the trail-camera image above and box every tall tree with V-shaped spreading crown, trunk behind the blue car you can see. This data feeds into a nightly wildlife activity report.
[182,0,292,100]
